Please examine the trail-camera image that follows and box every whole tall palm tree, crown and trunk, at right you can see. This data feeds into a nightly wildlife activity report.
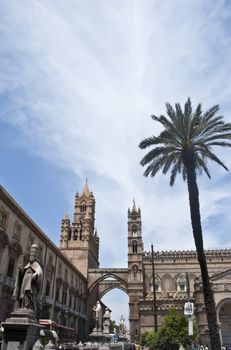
[139,98,231,350]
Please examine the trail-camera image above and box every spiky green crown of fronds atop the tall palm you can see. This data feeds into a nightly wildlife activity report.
[139,98,231,186]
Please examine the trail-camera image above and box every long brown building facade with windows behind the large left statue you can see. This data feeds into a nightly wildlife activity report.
[0,186,87,339]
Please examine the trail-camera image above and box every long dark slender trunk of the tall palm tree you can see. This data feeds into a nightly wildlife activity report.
[184,151,221,350]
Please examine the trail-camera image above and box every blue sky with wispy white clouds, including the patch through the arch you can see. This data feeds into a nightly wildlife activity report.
[0,0,231,322]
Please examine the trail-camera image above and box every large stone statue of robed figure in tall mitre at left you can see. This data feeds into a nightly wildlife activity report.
[14,244,43,310]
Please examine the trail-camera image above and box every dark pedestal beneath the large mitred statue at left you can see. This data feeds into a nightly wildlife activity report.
[2,309,43,350]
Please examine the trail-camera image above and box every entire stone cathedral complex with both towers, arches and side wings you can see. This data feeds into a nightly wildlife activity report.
[0,183,231,344]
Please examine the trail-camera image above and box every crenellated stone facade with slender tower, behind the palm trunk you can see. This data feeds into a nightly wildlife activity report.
[128,205,231,345]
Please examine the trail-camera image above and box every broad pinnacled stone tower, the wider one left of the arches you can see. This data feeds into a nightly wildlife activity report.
[60,182,99,277]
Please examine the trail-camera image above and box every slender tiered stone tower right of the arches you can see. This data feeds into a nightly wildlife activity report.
[128,201,143,341]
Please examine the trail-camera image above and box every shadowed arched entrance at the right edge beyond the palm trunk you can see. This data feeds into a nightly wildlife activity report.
[218,298,231,346]
